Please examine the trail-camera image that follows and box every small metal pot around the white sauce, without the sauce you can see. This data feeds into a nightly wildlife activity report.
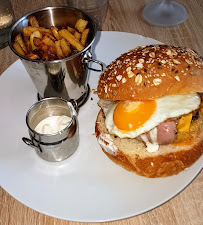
[22,97,79,162]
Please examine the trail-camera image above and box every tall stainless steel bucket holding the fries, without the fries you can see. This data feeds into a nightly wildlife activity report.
[9,6,103,106]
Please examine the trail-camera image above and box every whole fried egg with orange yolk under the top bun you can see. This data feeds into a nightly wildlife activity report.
[104,94,200,138]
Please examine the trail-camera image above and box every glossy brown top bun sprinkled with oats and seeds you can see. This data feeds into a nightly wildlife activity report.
[97,45,203,101]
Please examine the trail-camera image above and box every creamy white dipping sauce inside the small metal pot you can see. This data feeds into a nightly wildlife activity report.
[34,115,71,134]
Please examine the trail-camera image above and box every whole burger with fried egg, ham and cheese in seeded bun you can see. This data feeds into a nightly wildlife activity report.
[95,45,203,177]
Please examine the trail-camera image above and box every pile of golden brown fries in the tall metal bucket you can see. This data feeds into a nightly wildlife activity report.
[13,16,90,61]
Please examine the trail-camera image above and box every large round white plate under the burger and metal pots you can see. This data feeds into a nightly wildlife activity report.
[0,32,203,222]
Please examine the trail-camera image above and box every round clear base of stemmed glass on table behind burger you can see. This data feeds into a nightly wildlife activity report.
[143,0,187,26]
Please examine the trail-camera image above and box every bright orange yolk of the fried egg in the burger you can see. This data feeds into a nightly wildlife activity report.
[113,101,156,131]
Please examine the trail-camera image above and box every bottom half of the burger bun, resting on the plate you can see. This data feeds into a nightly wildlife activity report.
[95,110,203,178]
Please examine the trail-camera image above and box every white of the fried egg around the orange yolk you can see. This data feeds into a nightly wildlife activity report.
[105,94,201,138]
